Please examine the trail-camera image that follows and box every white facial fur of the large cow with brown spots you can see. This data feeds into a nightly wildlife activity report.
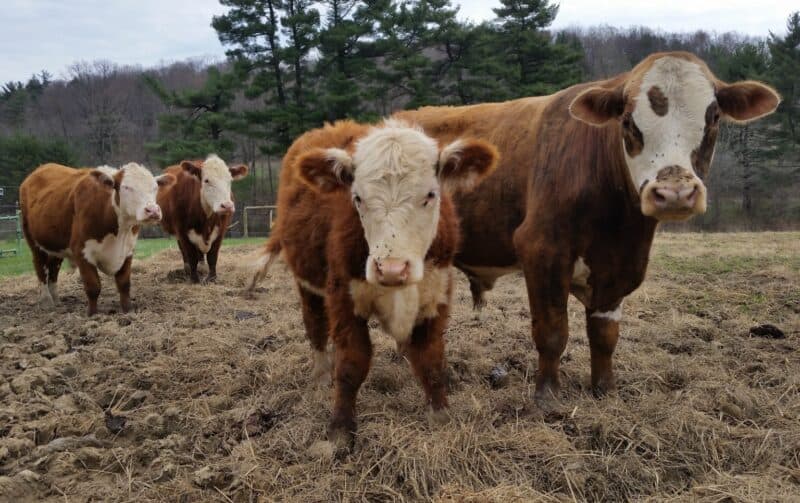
[623,56,715,188]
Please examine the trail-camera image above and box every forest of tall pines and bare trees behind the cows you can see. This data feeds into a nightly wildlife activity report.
[0,0,800,230]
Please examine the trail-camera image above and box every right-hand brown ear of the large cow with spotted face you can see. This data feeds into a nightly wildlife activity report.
[716,80,781,122]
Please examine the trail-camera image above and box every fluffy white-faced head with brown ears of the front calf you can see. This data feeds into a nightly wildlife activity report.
[299,121,497,286]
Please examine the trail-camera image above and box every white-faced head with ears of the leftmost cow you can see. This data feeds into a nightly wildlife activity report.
[92,162,175,224]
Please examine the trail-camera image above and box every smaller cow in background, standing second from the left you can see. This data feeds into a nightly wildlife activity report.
[157,154,248,283]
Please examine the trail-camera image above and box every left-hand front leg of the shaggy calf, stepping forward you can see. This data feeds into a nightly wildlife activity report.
[326,291,372,450]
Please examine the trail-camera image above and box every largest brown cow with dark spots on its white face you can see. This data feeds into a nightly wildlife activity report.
[396,52,780,404]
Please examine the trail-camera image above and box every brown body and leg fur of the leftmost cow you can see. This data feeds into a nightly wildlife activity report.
[19,163,138,316]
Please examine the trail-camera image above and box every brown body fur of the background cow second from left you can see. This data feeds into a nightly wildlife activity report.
[156,161,233,283]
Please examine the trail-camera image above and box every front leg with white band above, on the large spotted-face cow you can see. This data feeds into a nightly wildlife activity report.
[586,302,622,396]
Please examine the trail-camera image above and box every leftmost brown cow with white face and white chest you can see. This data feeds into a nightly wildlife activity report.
[19,163,174,316]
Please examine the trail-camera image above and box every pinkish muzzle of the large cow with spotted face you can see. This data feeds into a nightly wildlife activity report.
[641,166,706,220]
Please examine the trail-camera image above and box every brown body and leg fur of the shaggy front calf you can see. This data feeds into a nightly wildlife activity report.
[267,121,459,442]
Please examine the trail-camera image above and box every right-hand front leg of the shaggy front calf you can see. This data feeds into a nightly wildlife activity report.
[406,304,450,422]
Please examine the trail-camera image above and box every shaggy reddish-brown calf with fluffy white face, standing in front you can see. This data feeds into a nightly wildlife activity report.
[250,121,497,444]
